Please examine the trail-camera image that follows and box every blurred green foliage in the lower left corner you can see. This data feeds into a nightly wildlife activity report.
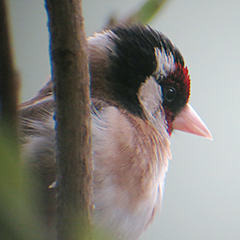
[0,126,44,240]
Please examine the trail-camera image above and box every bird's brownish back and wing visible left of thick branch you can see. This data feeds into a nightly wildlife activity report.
[19,80,56,232]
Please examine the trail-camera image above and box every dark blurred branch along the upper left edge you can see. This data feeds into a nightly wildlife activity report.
[0,0,18,140]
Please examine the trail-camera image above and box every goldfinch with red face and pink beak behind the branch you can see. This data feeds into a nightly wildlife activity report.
[19,24,212,240]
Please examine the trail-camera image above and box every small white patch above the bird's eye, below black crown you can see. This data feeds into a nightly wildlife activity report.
[155,47,176,77]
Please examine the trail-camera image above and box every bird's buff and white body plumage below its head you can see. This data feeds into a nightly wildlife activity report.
[20,78,170,239]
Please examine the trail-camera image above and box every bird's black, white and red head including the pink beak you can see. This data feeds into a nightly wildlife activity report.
[88,25,211,139]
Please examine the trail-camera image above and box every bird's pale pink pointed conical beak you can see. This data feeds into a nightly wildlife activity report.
[172,104,212,140]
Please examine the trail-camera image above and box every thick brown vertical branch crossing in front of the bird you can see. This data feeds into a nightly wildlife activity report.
[45,0,92,240]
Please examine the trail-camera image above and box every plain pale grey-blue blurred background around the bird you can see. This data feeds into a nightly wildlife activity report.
[9,0,240,240]
